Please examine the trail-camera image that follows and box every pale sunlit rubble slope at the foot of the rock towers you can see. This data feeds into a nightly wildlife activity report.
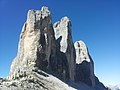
[0,69,76,90]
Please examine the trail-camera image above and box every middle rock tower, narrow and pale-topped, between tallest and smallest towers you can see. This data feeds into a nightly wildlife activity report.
[53,17,75,80]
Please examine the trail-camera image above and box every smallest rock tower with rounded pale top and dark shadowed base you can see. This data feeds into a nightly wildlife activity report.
[74,41,95,87]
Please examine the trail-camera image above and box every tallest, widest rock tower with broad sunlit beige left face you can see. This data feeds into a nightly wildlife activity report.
[9,7,56,79]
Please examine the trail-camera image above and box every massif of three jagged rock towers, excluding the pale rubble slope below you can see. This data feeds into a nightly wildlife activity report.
[7,7,105,89]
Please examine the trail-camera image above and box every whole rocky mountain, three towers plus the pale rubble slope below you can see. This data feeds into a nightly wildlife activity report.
[0,6,107,90]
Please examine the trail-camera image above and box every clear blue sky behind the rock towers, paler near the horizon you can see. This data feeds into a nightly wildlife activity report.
[0,0,120,84]
